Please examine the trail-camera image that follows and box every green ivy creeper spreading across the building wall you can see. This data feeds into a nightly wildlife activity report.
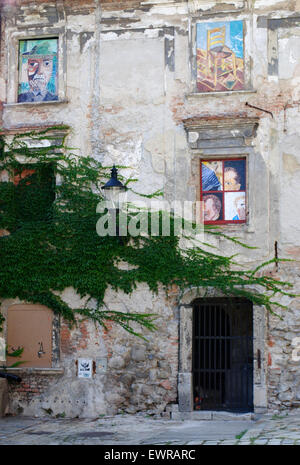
[0,127,292,334]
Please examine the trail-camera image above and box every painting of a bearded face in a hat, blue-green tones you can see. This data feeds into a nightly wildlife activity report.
[18,38,58,102]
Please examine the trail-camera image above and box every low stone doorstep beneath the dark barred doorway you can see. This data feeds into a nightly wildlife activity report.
[171,410,256,421]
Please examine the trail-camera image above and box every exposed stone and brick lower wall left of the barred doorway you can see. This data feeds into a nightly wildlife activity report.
[2,285,178,417]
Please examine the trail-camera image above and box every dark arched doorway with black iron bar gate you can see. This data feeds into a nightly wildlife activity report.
[193,298,253,412]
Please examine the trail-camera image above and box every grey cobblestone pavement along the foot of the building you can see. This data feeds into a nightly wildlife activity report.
[0,411,300,446]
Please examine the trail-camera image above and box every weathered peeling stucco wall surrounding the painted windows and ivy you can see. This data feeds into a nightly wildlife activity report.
[0,0,300,416]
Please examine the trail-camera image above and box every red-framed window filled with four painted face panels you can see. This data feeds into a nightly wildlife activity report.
[200,158,246,224]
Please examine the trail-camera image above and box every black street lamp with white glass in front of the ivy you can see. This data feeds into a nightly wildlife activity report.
[102,165,127,244]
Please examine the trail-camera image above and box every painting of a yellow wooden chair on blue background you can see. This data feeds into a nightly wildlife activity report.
[196,21,244,92]
